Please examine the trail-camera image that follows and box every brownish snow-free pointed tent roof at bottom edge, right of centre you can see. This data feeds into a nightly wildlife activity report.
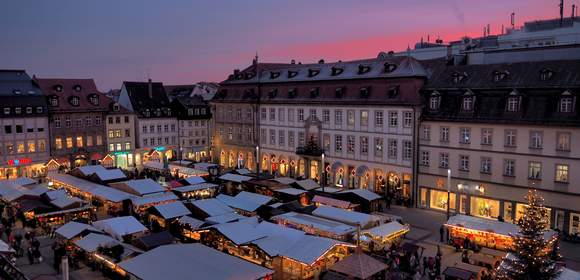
[330,253,387,279]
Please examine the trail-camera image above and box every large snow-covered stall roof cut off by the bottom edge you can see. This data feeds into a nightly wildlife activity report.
[118,244,274,280]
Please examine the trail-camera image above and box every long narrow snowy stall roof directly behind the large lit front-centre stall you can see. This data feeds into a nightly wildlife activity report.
[272,212,356,235]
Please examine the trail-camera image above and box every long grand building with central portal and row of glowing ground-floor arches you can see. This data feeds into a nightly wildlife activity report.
[214,56,426,201]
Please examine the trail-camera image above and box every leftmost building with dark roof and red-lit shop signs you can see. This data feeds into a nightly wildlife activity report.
[0,70,50,180]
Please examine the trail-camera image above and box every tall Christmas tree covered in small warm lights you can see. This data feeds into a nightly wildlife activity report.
[495,189,560,280]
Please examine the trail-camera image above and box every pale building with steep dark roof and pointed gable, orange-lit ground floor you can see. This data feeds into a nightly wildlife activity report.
[118,80,179,167]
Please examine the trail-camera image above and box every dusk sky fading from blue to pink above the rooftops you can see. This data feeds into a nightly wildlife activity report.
[0,0,564,91]
